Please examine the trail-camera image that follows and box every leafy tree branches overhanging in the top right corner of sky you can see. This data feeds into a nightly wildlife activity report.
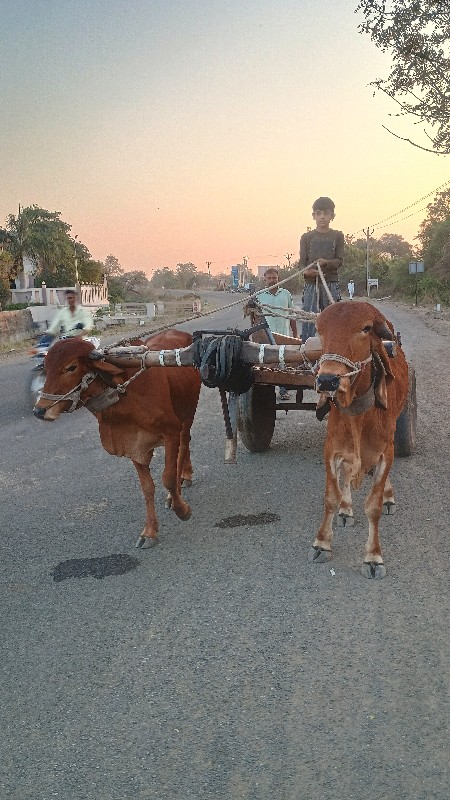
[356,0,450,155]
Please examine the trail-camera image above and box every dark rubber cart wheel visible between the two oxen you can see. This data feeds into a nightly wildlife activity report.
[238,384,277,453]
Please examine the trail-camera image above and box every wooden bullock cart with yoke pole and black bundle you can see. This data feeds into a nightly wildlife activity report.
[102,319,417,463]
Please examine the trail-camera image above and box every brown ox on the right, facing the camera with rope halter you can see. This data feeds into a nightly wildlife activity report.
[311,301,408,578]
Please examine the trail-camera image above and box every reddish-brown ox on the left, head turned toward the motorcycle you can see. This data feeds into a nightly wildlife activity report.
[35,330,200,547]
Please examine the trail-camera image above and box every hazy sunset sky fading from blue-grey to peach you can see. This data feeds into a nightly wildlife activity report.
[0,0,450,275]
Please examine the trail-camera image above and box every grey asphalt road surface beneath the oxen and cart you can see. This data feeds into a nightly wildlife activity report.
[0,295,450,800]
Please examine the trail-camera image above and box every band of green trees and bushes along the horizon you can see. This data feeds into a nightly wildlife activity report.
[0,189,450,309]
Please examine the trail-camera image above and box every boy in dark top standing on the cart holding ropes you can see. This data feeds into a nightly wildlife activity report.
[299,197,345,342]
